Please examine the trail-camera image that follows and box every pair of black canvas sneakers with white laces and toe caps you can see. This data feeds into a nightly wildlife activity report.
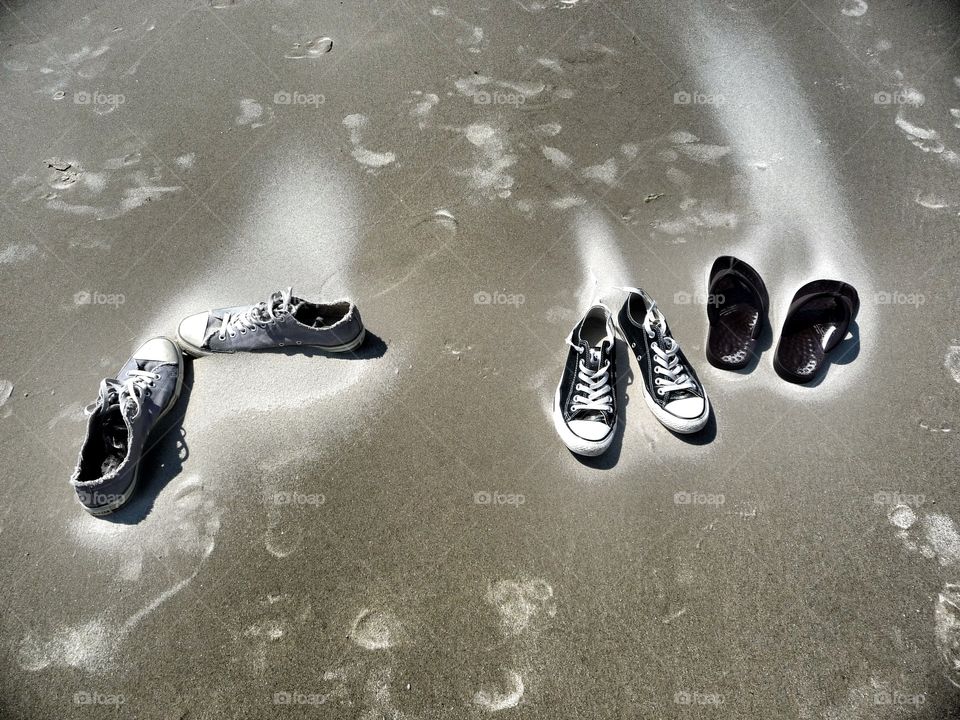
[553,288,710,455]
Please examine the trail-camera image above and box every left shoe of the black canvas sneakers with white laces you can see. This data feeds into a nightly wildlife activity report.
[553,305,617,455]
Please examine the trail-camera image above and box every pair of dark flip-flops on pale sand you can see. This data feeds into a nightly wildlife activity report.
[707,255,860,383]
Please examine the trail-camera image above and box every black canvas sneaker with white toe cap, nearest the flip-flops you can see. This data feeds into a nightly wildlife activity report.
[617,288,710,433]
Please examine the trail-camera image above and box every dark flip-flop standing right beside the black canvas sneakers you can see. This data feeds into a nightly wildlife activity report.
[707,255,770,370]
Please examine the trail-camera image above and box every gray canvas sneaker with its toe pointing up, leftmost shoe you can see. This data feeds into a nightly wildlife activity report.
[70,337,183,515]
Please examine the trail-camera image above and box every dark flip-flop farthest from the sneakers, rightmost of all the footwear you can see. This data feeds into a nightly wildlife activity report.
[773,280,860,383]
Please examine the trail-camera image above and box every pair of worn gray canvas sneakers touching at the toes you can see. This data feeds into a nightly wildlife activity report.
[70,288,366,515]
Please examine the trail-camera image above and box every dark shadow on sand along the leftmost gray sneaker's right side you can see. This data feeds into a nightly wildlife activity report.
[102,354,193,525]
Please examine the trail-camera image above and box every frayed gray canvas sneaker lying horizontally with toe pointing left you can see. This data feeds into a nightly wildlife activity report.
[177,288,366,357]
